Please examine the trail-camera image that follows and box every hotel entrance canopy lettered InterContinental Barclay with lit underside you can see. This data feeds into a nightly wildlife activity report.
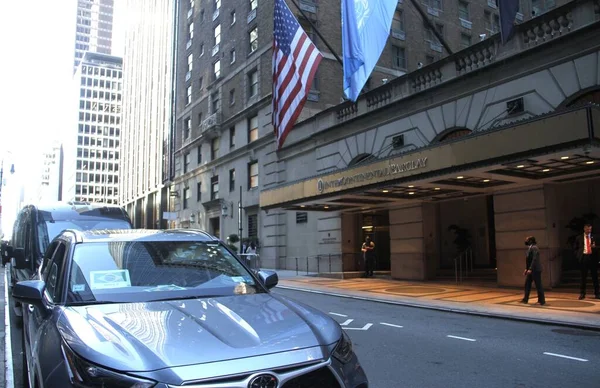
[260,105,600,212]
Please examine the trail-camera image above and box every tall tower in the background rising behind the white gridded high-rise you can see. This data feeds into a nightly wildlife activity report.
[73,0,114,72]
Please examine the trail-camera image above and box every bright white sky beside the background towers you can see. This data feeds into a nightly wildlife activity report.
[0,0,126,236]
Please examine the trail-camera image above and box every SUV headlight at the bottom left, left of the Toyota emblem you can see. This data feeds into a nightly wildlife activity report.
[62,344,156,388]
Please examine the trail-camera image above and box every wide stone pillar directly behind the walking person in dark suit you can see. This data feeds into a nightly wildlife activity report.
[494,186,560,290]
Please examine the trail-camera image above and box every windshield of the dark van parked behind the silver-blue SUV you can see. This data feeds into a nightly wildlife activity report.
[38,218,131,253]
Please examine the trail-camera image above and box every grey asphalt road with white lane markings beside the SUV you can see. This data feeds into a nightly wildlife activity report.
[274,288,600,388]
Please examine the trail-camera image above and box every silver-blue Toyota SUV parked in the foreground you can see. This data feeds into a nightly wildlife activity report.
[13,230,368,388]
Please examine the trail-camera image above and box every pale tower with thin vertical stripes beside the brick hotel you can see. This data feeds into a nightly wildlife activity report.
[119,0,176,228]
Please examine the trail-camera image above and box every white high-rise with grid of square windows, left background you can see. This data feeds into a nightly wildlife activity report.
[63,52,123,204]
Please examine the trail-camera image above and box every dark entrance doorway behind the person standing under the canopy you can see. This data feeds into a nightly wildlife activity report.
[358,210,390,271]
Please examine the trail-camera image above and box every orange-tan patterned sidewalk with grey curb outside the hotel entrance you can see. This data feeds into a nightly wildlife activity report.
[276,270,600,330]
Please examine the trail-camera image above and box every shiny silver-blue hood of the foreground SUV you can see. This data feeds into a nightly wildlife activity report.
[57,293,341,372]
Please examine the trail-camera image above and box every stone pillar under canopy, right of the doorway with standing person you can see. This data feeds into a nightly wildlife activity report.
[390,204,430,280]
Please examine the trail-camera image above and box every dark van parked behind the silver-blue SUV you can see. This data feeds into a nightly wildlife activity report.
[2,202,133,317]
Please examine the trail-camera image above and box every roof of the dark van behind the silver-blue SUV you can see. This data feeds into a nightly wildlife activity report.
[29,202,130,221]
